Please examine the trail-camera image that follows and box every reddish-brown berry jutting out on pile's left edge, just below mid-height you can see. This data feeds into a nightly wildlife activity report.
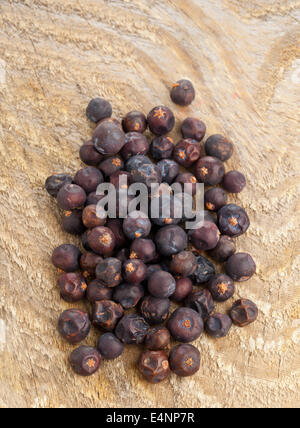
[52,244,81,272]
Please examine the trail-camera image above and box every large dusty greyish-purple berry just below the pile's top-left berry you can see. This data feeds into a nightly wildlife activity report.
[93,121,125,155]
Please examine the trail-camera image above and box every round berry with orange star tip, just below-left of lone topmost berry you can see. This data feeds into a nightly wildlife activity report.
[147,106,175,135]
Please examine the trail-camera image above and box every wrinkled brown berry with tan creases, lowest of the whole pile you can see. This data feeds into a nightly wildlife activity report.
[138,351,170,384]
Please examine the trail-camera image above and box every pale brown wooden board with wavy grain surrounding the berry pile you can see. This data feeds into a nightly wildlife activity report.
[0,0,300,408]
